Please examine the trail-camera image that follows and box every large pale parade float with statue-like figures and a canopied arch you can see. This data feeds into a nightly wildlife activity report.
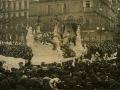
[26,15,83,65]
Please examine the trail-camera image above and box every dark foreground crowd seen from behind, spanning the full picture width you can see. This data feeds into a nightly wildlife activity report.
[0,58,120,90]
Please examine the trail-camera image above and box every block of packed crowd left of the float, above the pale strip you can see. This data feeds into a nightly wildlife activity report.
[0,44,33,60]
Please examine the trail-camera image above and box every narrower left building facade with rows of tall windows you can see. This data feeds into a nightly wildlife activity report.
[0,0,29,42]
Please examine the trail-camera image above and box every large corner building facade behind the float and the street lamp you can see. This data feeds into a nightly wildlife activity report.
[29,0,120,41]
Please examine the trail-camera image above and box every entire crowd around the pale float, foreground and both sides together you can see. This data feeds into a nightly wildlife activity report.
[0,41,120,90]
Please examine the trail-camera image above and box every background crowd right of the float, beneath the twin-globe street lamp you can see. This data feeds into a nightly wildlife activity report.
[82,41,120,59]
